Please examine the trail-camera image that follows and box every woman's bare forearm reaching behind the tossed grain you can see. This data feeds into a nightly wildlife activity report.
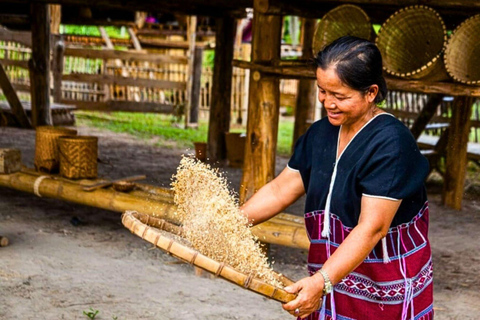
[240,168,305,225]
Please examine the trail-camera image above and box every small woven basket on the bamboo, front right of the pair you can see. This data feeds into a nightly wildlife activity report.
[58,136,98,179]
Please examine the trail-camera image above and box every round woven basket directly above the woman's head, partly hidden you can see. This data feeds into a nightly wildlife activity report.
[312,4,373,56]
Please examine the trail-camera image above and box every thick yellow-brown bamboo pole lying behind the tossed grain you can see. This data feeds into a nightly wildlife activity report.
[0,170,310,249]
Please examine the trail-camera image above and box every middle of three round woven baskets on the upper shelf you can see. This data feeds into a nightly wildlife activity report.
[376,6,448,81]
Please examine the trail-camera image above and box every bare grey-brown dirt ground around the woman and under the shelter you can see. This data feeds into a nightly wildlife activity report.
[0,127,480,320]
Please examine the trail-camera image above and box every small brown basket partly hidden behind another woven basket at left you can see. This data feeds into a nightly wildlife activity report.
[34,126,77,173]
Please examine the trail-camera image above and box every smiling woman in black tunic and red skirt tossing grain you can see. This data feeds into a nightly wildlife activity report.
[242,37,433,320]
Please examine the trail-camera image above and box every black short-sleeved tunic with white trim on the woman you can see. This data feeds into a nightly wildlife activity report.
[288,113,428,227]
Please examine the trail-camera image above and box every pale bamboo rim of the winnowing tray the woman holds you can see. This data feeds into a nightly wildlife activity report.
[122,211,296,303]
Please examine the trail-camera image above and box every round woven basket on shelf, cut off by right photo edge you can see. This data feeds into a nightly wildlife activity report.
[444,14,480,84]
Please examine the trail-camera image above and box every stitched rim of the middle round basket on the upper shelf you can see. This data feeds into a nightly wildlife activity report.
[375,5,448,78]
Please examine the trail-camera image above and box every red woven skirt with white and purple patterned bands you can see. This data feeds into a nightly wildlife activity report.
[305,203,433,320]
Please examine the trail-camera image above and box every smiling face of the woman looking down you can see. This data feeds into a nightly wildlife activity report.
[317,67,378,126]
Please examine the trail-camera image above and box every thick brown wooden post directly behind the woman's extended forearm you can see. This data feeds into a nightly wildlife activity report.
[240,6,282,202]
